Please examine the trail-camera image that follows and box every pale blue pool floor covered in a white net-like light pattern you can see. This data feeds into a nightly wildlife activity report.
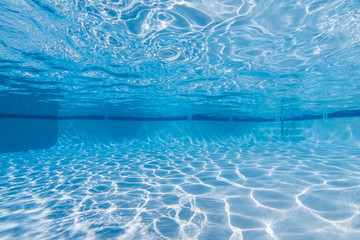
[0,140,360,240]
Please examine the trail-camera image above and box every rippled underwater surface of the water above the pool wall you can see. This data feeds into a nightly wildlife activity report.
[0,0,360,117]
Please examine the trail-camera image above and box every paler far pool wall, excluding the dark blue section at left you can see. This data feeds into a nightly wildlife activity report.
[58,118,360,144]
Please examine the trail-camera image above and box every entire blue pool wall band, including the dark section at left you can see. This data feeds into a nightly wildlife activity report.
[0,118,360,153]
